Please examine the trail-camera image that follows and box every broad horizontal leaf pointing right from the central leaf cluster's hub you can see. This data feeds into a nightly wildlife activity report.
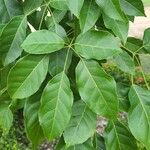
[75,31,121,60]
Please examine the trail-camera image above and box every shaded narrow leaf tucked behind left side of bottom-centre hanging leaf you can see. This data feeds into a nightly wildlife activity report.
[24,92,44,148]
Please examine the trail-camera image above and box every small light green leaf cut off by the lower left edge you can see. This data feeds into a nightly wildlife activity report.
[0,102,13,134]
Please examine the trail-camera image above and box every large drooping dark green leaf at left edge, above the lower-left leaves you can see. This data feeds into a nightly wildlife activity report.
[0,16,27,65]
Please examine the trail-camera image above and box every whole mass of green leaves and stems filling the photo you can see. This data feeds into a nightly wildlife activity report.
[0,0,150,150]
